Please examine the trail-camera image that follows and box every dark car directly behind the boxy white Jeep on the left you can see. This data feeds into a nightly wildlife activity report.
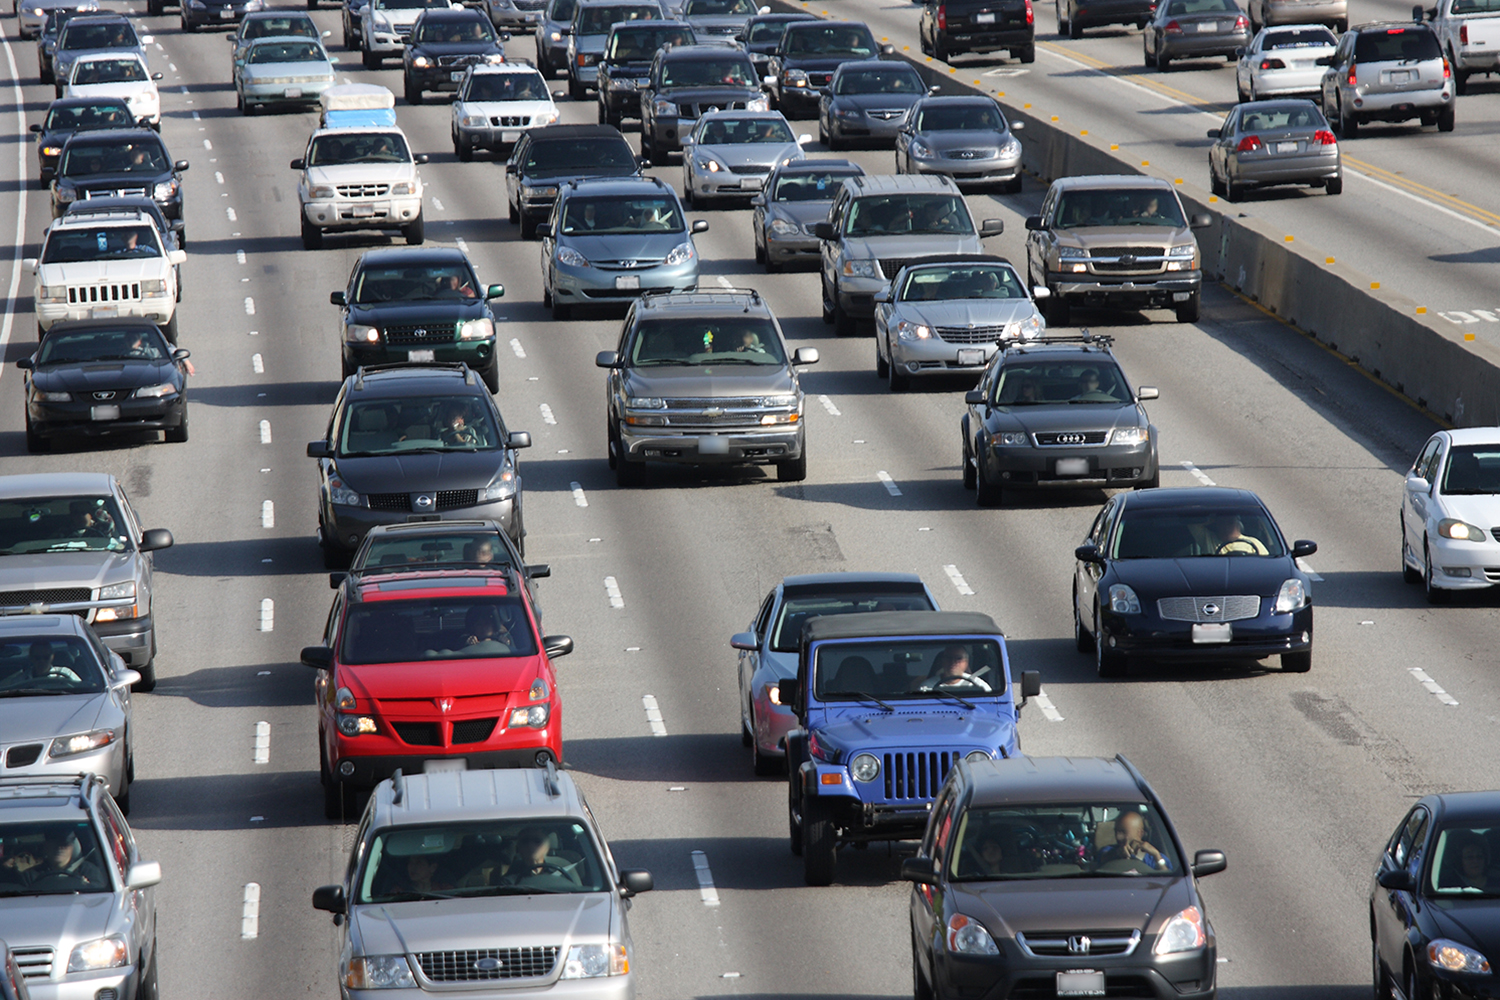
[53,129,189,249]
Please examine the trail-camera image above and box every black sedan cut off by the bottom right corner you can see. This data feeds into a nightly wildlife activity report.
[1370,792,1500,1000]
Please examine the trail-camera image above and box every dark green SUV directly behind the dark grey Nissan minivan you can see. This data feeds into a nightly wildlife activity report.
[329,246,506,393]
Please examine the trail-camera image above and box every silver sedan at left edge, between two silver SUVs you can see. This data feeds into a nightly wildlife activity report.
[0,615,141,816]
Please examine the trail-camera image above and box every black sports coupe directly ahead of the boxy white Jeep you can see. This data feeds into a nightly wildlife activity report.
[15,319,188,453]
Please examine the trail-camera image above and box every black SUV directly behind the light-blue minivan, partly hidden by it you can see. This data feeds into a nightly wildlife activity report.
[506,124,641,240]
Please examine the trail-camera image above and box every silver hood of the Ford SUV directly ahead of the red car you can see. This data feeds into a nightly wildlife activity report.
[354,892,615,961]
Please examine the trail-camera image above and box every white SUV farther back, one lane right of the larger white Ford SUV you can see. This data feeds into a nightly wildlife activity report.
[450,63,558,163]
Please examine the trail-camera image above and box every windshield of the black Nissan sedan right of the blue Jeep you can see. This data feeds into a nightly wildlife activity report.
[1113,508,1286,560]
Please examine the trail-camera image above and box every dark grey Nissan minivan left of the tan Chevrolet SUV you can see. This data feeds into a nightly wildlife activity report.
[308,364,531,570]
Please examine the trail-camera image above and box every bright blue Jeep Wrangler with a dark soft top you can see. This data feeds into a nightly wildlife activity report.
[783,612,1041,886]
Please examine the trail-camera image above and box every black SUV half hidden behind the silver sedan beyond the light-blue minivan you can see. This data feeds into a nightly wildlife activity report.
[641,45,767,166]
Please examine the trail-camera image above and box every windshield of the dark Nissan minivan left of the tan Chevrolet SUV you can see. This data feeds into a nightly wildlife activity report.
[339,395,501,455]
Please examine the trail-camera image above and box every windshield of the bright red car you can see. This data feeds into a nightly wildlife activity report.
[339,593,537,666]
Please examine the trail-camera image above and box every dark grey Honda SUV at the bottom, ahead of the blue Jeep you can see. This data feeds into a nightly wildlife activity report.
[902,756,1227,1000]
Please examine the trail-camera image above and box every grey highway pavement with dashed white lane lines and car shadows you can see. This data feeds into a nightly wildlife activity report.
[0,3,1500,1000]
